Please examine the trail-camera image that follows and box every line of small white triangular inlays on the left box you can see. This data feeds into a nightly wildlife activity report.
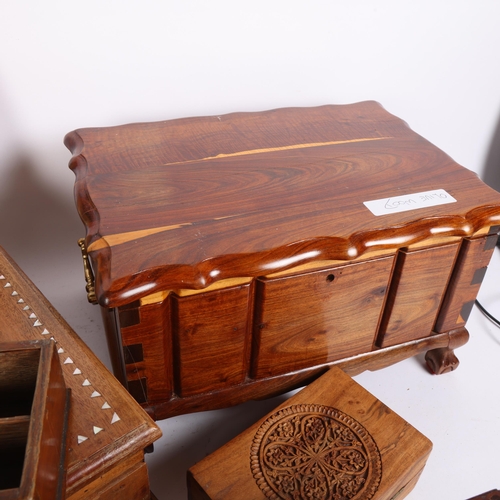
[0,274,121,445]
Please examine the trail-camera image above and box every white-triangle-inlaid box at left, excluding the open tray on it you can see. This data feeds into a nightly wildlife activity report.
[0,248,161,500]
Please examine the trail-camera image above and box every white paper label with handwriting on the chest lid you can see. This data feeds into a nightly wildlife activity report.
[363,189,457,216]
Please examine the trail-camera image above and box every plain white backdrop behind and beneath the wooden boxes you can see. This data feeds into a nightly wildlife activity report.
[0,0,500,500]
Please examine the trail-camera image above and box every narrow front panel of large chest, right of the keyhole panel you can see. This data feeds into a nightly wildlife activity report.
[377,243,459,347]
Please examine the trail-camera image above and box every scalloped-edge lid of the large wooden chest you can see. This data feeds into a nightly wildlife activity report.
[65,102,500,307]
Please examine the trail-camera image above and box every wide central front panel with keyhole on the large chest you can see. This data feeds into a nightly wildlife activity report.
[252,256,393,378]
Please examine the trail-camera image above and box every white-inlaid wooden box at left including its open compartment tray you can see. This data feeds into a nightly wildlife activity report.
[0,247,161,500]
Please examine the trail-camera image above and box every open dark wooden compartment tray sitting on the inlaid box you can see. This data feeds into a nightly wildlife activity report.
[0,340,70,500]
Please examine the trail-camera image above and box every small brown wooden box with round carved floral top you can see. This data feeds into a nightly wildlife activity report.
[188,367,432,500]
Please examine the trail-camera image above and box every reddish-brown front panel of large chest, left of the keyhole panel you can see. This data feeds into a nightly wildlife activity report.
[172,284,252,397]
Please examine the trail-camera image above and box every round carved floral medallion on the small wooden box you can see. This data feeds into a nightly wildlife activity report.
[250,405,382,500]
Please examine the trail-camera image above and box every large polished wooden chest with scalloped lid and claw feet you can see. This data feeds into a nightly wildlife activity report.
[65,102,500,419]
